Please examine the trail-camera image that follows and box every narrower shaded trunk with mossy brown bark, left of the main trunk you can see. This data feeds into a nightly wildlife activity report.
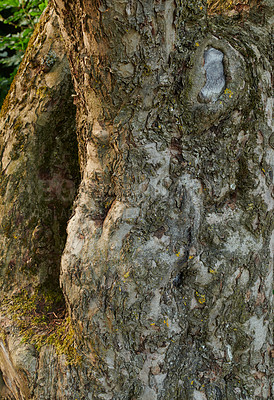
[0,8,80,399]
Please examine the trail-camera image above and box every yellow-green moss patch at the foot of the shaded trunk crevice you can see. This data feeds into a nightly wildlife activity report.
[2,287,81,364]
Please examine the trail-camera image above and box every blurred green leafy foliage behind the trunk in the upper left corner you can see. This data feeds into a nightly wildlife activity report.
[0,0,48,107]
